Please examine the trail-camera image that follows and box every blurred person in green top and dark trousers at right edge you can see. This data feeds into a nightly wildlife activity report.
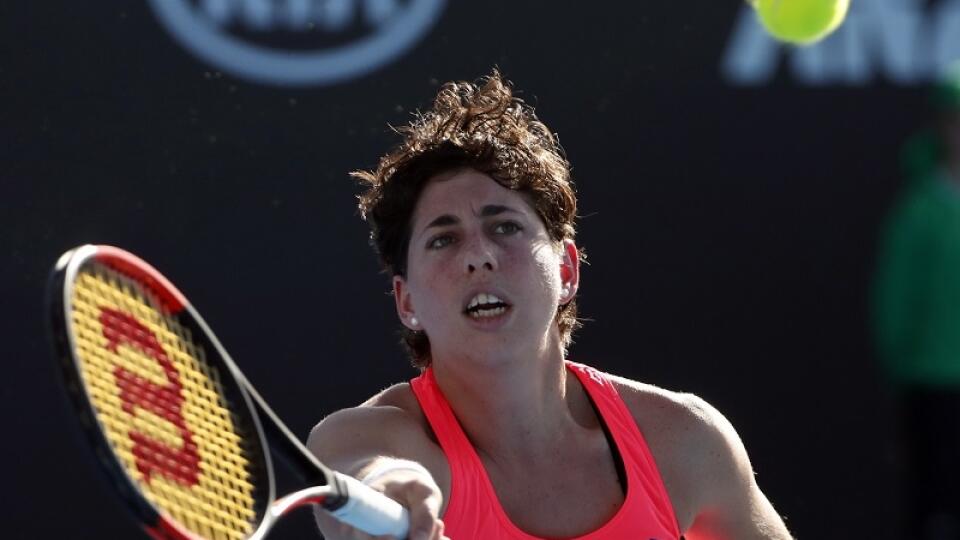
[873,63,960,540]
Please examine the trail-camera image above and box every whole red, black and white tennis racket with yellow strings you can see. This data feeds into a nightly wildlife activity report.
[49,245,408,540]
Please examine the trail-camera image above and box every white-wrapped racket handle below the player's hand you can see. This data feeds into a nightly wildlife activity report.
[330,472,410,538]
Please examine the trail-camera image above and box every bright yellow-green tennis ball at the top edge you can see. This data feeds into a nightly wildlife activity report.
[748,0,850,45]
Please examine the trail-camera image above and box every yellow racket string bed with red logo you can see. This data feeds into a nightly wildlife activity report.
[70,265,264,539]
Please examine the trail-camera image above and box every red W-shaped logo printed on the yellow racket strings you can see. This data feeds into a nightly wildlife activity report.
[100,308,200,486]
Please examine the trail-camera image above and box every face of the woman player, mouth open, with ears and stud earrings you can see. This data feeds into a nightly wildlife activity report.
[394,169,579,362]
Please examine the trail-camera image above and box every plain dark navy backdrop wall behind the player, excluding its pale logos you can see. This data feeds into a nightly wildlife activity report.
[0,0,925,539]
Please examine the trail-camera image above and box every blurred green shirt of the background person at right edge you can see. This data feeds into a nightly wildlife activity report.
[874,171,960,387]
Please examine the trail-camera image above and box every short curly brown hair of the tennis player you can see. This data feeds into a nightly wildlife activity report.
[350,70,583,369]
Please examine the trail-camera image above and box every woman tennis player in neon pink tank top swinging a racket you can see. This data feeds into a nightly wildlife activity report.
[308,72,790,540]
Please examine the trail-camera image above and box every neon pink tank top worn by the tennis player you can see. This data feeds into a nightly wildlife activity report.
[410,362,680,540]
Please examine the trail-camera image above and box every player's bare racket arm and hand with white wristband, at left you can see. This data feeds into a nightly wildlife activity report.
[307,398,446,540]
